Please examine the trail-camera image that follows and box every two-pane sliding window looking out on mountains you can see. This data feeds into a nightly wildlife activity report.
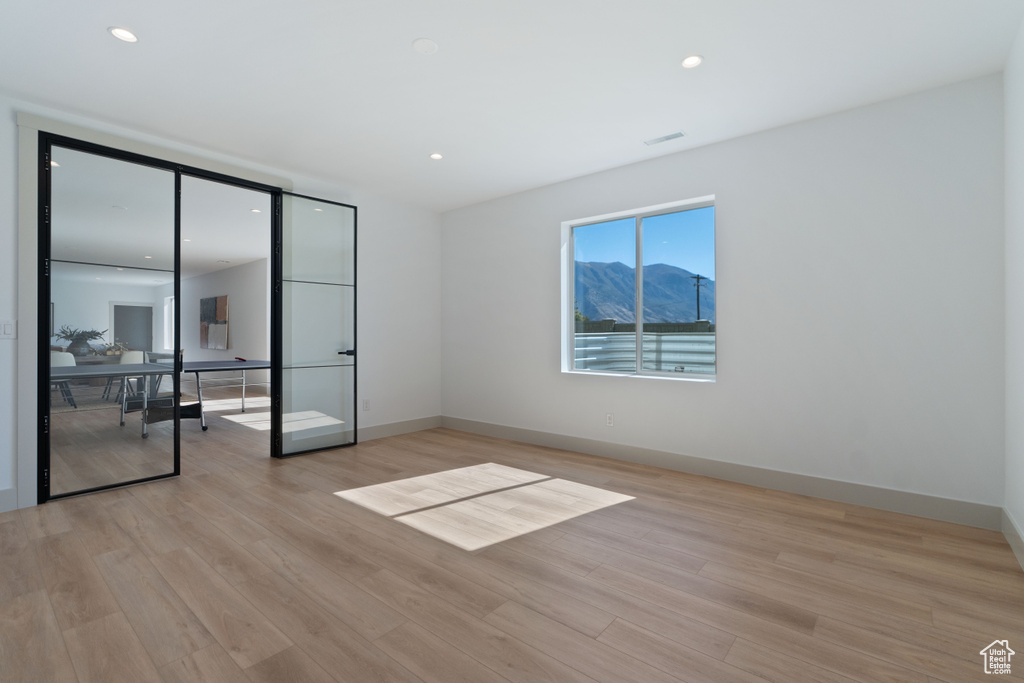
[562,198,716,380]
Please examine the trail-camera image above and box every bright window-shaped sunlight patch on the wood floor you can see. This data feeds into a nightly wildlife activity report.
[335,463,633,551]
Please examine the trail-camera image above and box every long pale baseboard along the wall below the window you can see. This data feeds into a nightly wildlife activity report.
[441,417,1004,531]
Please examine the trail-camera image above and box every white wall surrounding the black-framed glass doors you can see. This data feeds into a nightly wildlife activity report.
[0,93,440,511]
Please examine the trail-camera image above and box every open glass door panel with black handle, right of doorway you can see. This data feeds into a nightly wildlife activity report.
[279,193,356,456]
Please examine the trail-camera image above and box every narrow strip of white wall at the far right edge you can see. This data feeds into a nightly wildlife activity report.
[1005,21,1024,540]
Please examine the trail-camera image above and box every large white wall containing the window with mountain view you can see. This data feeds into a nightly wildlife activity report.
[441,76,1004,505]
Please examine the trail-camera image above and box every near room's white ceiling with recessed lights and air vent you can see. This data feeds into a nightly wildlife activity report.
[0,0,1024,211]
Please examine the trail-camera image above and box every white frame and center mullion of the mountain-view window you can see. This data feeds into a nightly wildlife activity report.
[560,195,718,382]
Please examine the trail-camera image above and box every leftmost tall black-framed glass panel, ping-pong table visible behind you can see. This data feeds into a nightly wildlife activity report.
[46,145,178,498]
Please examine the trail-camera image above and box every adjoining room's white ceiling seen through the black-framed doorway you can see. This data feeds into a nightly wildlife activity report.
[50,146,271,280]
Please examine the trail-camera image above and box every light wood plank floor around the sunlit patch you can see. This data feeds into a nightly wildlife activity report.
[0,397,1024,683]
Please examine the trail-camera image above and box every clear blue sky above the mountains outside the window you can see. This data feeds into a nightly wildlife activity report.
[573,207,715,280]
